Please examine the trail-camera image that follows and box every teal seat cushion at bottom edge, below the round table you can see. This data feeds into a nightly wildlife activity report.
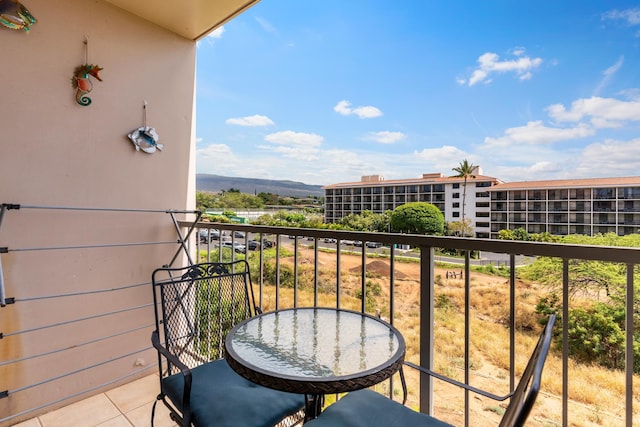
[304,390,451,427]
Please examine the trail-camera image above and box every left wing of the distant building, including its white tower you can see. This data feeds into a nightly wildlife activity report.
[324,167,501,238]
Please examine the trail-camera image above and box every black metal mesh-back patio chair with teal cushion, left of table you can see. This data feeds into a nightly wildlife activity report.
[151,260,305,427]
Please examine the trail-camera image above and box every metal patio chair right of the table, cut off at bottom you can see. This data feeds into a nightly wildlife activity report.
[305,315,555,427]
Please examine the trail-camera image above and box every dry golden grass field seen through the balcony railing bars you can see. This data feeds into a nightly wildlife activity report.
[256,248,640,427]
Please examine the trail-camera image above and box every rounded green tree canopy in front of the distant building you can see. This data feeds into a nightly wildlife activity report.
[391,202,444,235]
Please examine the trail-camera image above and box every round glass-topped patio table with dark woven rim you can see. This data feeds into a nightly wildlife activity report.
[225,308,405,395]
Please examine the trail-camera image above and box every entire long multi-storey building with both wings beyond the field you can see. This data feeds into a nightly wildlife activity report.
[324,168,640,238]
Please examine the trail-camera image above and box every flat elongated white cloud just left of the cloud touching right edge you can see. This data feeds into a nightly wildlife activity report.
[484,120,595,147]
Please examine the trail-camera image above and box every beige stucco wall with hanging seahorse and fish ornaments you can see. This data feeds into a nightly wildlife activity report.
[0,0,196,425]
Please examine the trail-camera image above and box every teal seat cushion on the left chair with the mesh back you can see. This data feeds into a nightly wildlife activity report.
[162,359,304,427]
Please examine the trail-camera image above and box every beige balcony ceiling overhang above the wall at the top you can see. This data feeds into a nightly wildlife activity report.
[105,0,260,40]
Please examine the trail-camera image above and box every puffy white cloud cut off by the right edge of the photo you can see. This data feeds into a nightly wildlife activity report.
[547,96,640,128]
